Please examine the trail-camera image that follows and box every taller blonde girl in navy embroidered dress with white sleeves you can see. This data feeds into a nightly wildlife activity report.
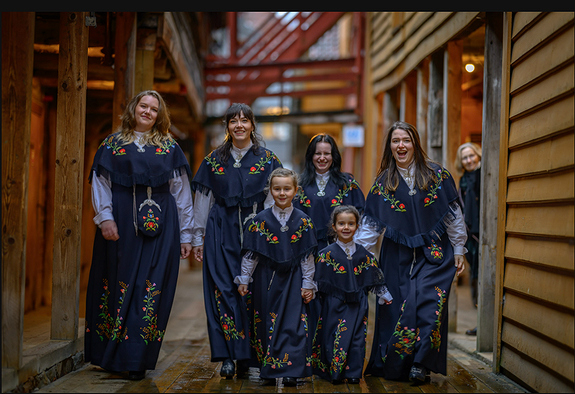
[234,168,317,386]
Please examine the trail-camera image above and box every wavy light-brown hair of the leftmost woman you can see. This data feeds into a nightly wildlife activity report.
[116,90,172,146]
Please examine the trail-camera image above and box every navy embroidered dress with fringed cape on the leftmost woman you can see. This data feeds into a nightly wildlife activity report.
[84,133,191,371]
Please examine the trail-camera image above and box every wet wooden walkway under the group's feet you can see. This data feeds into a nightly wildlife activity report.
[35,265,528,393]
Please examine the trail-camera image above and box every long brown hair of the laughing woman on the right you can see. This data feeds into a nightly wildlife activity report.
[376,121,439,192]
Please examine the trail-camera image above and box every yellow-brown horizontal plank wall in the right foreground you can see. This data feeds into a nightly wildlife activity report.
[498,12,575,392]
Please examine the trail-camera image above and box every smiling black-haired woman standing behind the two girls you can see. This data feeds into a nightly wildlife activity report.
[294,133,365,350]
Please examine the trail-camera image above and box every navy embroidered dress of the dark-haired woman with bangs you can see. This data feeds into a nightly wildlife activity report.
[192,147,282,362]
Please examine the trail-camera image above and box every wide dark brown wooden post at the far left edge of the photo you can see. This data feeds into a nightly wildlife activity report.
[2,12,35,369]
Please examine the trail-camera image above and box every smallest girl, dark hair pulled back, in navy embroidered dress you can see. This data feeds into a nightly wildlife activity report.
[309,205,392,384]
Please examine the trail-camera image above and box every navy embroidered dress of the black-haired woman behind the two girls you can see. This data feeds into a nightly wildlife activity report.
[293,173,365,250]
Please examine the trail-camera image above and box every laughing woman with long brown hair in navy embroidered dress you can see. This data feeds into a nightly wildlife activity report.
[356,122,467,384]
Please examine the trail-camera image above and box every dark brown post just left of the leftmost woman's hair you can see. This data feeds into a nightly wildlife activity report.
[112,12,136,130]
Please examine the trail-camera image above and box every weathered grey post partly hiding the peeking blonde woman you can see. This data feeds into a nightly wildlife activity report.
[476,12,503,352]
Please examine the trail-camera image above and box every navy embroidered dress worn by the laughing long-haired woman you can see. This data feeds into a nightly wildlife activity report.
[365,165,464,380]
